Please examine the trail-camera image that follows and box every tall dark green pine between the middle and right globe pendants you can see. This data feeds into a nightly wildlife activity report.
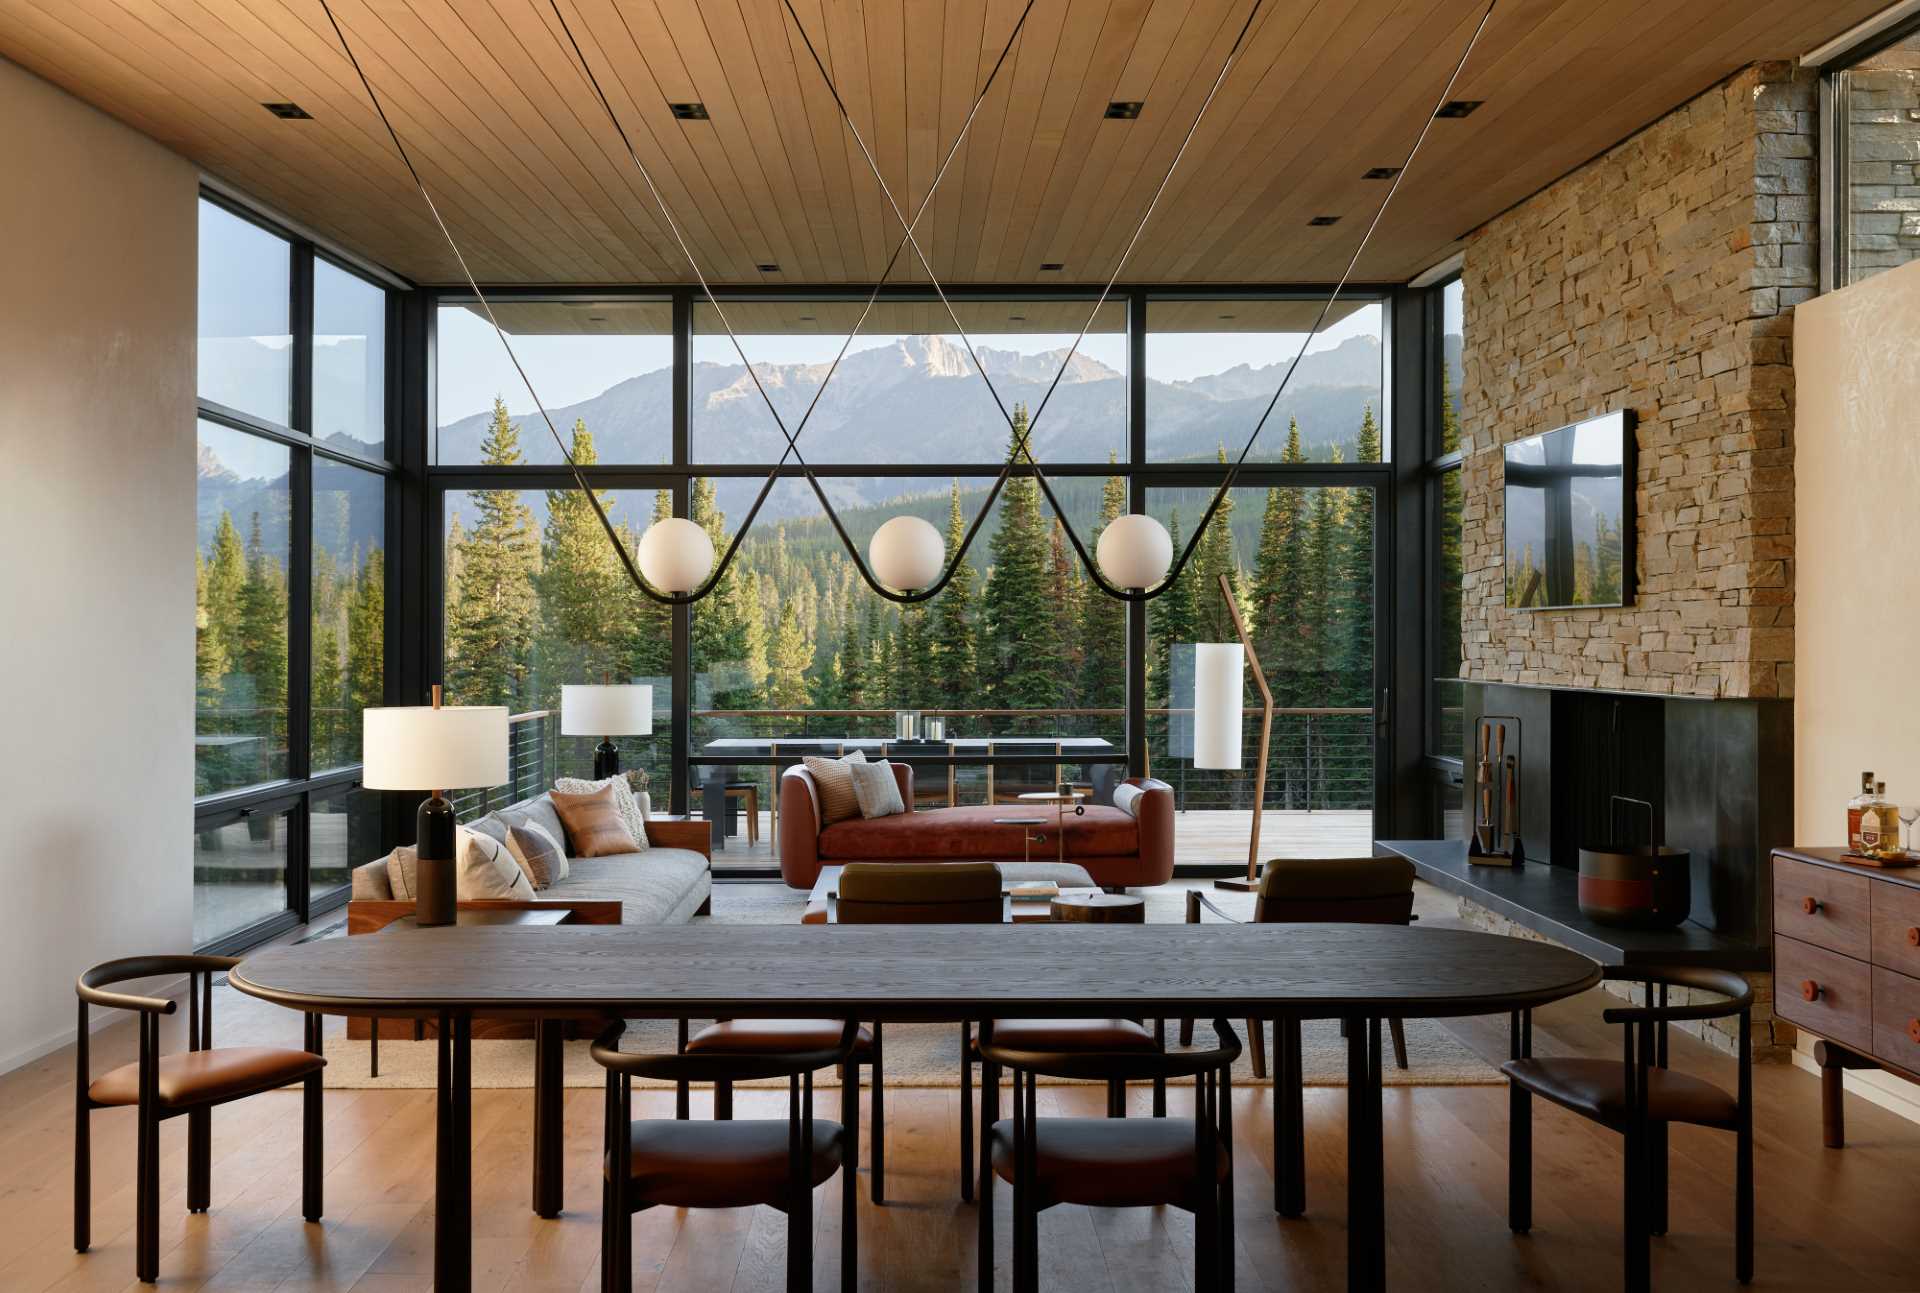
[981,403,1062,722]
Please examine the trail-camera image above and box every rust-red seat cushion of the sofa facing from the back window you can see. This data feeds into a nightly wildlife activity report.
[820,803,1140,863]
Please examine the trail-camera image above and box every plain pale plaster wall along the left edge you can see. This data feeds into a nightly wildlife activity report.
[0,60,198,1072]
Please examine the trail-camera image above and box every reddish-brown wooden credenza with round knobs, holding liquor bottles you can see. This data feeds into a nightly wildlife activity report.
[1774,849,1920,1149]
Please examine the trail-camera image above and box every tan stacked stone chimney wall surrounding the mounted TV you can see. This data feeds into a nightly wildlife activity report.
[1461,63,1818,697]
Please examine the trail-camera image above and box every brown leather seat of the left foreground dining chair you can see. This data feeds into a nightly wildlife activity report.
[607,1122,841,1208]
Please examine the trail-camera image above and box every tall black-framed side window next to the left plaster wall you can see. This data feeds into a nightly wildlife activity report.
[194,198,392,947]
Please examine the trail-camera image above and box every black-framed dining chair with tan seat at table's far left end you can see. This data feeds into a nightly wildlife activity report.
[73,955,326,1283]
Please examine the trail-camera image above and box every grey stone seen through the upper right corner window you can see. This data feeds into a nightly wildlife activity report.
[1847,40,1920,282]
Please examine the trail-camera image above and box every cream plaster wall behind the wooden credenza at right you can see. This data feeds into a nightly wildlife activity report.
[1793,263,1920,1114]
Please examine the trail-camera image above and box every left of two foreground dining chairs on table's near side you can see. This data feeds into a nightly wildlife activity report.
[593,1020,860,1293]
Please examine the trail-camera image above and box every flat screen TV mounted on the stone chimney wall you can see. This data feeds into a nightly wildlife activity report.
[1507,409,1634,611]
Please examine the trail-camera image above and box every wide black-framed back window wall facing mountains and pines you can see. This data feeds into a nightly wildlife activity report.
[430,288,1390,866]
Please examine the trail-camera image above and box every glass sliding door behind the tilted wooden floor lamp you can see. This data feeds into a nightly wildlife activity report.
[1146,473,1379,863]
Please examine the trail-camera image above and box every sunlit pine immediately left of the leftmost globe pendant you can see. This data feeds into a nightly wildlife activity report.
[534,421,632,694]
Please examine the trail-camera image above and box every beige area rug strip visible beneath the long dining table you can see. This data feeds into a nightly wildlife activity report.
[326,1020,1505,1089]
